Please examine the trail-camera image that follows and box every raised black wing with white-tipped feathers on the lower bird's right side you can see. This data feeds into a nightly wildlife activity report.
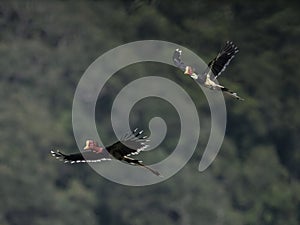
[106,129,149,160]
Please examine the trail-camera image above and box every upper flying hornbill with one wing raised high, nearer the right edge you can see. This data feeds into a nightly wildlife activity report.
[173,41,244,100]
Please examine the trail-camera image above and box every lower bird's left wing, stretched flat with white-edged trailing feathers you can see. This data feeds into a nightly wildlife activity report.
[51,150,111,164]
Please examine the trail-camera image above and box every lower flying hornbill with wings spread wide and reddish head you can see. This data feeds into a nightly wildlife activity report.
[51,129,161,176]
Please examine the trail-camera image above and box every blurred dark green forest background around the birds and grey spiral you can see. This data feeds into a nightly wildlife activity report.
[0,0,300,225]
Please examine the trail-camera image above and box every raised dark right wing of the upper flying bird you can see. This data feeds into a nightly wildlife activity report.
[208,41,239,79]
